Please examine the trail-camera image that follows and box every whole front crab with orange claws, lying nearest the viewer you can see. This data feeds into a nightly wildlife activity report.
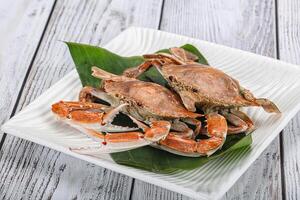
[52,67,227,156]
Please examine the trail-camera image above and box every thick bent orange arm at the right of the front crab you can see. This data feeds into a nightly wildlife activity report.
[160,113,227,156]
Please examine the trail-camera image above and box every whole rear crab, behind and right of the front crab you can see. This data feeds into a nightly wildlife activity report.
[123,47,280,138]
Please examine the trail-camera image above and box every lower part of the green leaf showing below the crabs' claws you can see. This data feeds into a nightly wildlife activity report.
[111,134,252,173]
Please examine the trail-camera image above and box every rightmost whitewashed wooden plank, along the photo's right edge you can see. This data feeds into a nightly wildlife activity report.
[278,0,300,199]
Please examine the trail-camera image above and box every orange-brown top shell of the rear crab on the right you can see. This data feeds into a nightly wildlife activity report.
[161,64,257,106]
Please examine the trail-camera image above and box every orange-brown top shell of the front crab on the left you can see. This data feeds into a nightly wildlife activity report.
[103,78,200,121]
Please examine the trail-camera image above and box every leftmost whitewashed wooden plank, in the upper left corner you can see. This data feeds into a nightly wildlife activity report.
[0,0,54,139]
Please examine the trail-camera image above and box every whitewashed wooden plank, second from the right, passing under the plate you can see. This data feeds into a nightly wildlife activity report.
[132,0,281,199]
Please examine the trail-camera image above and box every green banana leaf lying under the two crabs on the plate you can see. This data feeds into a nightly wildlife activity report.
[66,42,252,173]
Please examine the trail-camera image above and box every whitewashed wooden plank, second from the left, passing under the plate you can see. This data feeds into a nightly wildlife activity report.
[0,0,162,199]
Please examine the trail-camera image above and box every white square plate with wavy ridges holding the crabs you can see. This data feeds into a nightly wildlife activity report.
[2,28,300,199]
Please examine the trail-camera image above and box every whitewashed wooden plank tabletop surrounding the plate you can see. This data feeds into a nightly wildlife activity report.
[0,0,300,199]
